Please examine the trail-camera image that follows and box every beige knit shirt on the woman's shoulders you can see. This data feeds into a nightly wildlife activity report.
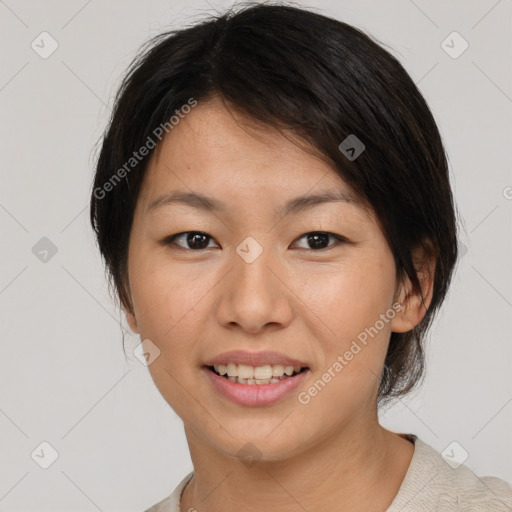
[146,434,512,512]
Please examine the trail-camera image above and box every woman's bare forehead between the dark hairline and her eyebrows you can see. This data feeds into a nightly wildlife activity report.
[141,99,374,220]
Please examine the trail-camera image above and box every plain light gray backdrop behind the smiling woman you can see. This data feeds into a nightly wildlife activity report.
[0,0,512,512]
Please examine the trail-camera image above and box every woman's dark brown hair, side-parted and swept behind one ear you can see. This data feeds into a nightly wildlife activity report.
[90,4,457,403]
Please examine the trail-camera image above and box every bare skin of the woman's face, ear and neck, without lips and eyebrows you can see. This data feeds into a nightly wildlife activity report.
[126,98,433,512]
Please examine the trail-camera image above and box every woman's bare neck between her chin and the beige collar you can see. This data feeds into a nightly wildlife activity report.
[181,417,414,512]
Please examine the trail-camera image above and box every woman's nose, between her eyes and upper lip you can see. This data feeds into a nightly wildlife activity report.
[217,241,293,334]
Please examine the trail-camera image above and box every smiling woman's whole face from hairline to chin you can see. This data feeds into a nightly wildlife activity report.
[127,96,419,460]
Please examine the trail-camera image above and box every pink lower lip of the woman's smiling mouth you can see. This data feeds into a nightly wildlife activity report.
[203,367,309,407]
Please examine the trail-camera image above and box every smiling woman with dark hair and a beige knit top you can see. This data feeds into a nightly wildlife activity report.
[91,5,512,512]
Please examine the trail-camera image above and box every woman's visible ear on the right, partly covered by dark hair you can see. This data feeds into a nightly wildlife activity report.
[391,243,435,332]
